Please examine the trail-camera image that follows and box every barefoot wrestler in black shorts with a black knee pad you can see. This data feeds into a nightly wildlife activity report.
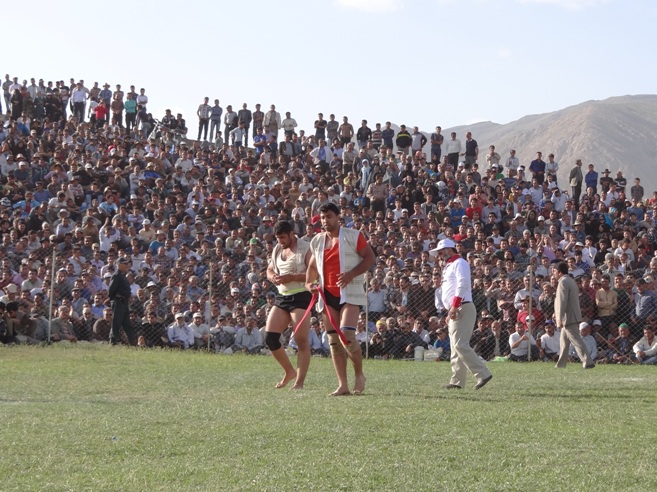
[265,221,312,390]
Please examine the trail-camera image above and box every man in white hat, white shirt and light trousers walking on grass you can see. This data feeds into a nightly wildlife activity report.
[432,239,493,389]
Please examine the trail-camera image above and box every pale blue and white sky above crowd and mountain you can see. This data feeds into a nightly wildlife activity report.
[0,0,657,133]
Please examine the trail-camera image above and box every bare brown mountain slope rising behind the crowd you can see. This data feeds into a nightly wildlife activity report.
[440,95,657,195]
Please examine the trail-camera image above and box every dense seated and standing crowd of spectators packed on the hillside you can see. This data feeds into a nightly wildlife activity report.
[0,75,657,363]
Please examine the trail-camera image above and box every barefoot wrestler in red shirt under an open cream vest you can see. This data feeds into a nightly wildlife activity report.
[306,202,375,396]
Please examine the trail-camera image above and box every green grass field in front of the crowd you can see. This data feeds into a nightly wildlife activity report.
[0,345,657,491]
